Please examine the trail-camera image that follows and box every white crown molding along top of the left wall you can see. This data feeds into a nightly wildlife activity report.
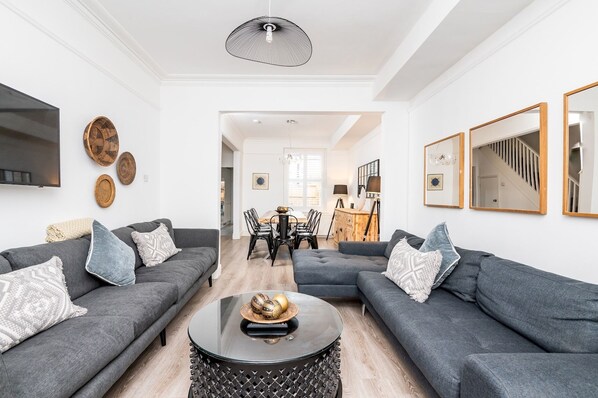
[64,0,166,82]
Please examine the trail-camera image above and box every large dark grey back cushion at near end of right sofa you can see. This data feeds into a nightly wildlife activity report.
[476,257,598,353]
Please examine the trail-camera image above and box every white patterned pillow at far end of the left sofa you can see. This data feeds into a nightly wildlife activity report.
[131,223,181,267]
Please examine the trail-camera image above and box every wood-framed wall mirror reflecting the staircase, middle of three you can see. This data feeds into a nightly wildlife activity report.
[469,102,547,214]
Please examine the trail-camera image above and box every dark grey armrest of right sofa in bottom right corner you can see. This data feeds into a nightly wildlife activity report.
[461,353,598,398]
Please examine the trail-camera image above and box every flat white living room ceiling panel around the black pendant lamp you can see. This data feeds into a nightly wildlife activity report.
[79,0,431,75]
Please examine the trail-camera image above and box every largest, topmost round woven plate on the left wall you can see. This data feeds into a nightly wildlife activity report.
[83,116,119,166]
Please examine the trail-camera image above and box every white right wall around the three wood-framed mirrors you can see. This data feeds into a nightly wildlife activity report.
[408,0,598,283]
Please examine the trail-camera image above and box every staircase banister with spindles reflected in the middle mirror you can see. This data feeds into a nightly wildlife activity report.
[487,137,540,192]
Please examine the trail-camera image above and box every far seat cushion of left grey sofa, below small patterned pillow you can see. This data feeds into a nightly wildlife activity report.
[135,260,203,302]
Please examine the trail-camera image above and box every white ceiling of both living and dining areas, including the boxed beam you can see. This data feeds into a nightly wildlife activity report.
[72,0,542,143]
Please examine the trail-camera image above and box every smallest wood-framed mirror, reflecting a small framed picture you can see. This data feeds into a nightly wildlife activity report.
[424,133,465,209]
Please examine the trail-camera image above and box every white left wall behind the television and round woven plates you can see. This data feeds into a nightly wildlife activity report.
[0,0,160,249]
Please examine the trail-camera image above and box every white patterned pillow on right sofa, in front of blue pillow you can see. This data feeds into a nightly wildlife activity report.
[382,238,442,303]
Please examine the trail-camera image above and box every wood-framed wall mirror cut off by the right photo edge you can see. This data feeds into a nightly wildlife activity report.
[563,82,598,217]
